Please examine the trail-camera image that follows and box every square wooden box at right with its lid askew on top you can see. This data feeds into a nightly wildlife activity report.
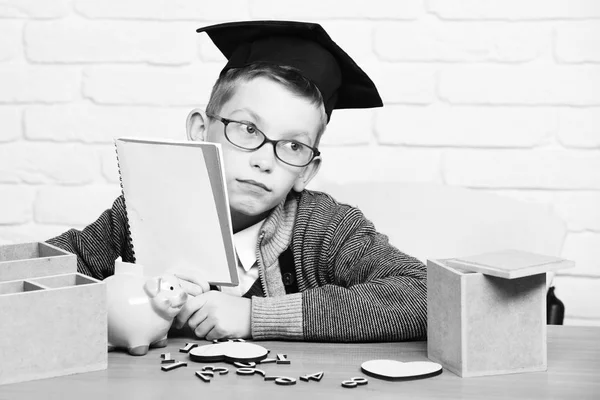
[427,251,573,377]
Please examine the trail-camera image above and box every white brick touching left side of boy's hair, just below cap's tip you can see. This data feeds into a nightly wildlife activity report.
[83,63,223,107]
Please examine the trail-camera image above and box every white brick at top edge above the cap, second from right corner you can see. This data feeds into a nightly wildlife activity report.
[250,0,424,20]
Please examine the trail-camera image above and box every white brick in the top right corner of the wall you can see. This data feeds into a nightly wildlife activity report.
[427,0,600,20]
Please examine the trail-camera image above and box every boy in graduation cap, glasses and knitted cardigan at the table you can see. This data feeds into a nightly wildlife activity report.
[49,21,426,341]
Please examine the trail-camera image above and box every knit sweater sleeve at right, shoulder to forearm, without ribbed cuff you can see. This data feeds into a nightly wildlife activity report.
[294,193,427,341]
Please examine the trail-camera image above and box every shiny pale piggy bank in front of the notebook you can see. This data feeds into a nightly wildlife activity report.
[104,262,187,356]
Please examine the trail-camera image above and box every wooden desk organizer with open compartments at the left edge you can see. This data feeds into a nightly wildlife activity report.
[0,243,107,385]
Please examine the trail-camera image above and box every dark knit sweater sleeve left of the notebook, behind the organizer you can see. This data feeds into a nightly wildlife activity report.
[47,196,134,280]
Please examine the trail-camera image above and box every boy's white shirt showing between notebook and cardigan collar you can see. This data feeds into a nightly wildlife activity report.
[221,219,264,297]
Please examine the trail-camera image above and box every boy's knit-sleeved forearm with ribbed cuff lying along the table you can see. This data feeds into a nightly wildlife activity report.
[251,277,427,342]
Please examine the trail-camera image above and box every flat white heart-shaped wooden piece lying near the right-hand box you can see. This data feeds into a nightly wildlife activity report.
[361,360,442,381]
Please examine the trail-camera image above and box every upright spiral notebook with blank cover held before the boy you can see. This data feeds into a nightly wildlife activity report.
[115,138,238,286]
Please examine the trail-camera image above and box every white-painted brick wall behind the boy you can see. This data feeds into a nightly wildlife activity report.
[0,0,600,325]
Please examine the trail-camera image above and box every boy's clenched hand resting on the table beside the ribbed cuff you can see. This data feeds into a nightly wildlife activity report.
[175,290,252,340]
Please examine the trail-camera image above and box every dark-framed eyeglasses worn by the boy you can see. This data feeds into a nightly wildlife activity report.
[206,114,321,167]
